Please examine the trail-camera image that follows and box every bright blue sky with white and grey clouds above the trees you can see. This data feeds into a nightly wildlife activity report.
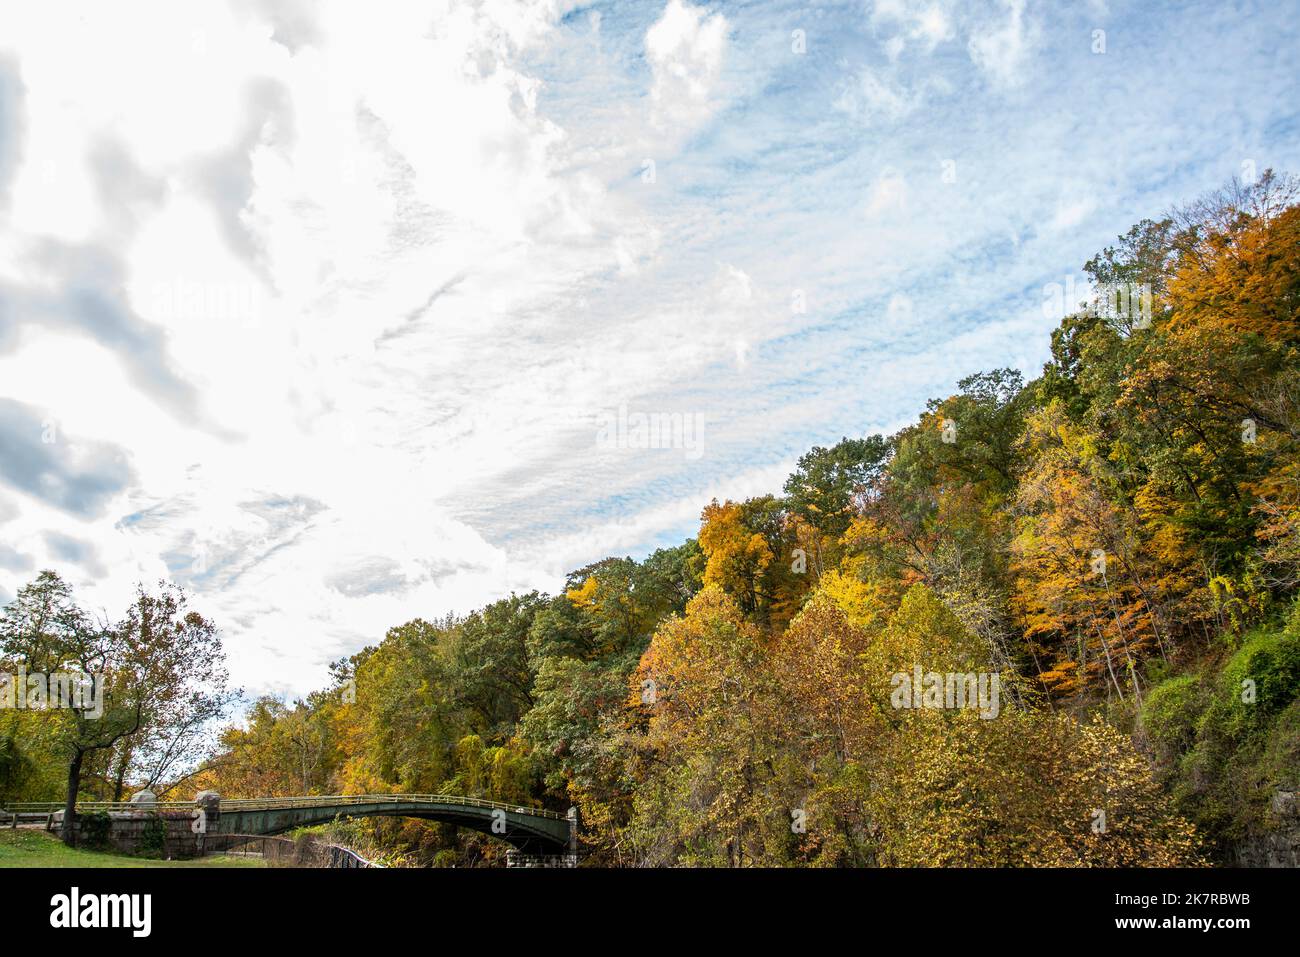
[0,0,1300,696]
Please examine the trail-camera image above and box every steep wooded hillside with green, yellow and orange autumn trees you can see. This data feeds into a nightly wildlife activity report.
[0,174,1300,866]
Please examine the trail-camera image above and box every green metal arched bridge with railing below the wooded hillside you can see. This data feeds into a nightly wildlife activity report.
[0,794,577,854]
